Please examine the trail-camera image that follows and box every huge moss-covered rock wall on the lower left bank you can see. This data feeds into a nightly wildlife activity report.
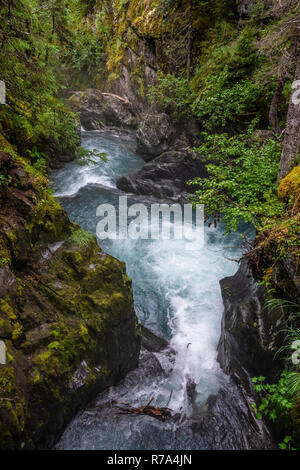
[0,152,140,449]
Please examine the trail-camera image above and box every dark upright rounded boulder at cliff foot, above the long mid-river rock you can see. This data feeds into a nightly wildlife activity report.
[136,113,175,161]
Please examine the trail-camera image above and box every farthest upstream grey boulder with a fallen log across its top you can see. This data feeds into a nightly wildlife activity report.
[69,88,137,131]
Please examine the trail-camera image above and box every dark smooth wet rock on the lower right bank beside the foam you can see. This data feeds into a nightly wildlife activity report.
[218,260,286,395]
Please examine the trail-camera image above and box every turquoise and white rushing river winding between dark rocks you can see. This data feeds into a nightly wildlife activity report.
[52,127,250,449]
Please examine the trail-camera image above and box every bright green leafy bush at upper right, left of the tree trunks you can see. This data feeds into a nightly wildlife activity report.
[192,25,274,129]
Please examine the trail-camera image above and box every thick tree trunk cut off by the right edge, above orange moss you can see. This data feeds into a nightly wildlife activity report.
[278,52,300,181]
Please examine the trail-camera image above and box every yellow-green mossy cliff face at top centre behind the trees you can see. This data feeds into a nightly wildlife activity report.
[89,0,219,113]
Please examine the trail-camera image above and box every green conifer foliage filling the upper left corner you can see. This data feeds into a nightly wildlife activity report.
[0,0,101,160]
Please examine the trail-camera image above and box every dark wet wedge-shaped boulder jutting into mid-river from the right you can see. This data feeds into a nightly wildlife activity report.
[117,149,206,200]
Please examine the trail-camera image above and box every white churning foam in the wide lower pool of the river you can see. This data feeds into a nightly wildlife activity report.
[102,216,239,410]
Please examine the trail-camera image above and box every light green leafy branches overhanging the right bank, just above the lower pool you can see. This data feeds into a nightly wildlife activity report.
[188,128,284,233]
